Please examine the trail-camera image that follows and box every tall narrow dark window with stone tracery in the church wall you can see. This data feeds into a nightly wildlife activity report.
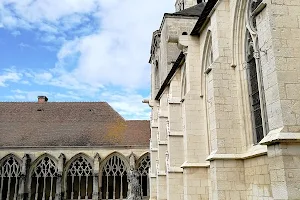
[246,0,267,143]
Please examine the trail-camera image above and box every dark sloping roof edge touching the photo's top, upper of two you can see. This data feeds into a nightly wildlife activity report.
[191,0,218,35]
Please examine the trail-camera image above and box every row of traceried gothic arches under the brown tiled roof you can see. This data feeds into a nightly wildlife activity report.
[0,152,150,200]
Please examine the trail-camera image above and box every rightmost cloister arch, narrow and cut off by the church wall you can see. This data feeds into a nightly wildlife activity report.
[138,153,150,197]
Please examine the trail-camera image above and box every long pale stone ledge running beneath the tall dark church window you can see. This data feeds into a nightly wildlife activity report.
[206,145,268,161]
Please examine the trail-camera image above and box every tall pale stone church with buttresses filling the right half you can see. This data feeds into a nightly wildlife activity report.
[147,0,300,200]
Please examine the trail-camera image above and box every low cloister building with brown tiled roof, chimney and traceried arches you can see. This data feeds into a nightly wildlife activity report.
[0,96,150,200]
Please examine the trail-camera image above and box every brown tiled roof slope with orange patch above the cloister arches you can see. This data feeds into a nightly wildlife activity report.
[0,102,150,147]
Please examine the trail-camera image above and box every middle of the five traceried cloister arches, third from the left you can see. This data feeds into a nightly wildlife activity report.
[67,156,93,199]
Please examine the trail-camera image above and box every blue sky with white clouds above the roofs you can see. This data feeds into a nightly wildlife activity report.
[0,0,175,119]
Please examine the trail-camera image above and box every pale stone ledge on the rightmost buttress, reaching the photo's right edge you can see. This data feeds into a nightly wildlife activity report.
[259,127,300,145]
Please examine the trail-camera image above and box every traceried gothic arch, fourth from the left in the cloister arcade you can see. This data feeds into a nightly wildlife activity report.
[102,155,128,199]
